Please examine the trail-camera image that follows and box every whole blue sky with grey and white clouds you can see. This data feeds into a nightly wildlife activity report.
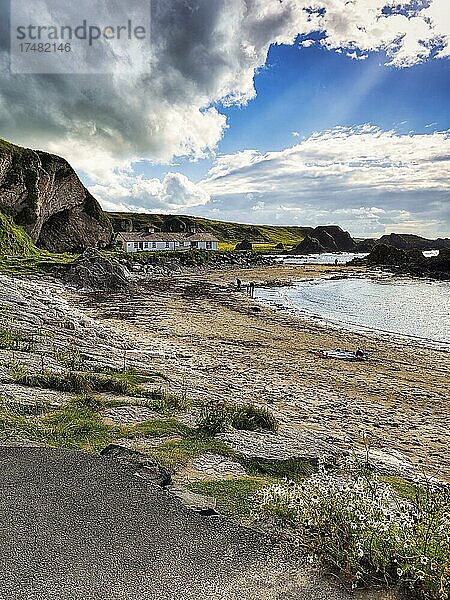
[0,0,450,237]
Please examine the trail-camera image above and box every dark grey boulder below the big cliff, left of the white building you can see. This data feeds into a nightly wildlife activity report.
[64,248,132,291]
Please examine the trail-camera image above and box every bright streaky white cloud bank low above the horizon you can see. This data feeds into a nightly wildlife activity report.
[91,125,450,236]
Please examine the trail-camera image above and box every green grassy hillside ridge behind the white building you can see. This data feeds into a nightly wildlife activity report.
[107,213,311,245]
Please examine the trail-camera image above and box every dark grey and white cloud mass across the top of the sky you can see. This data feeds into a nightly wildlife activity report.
[0,0,450,176]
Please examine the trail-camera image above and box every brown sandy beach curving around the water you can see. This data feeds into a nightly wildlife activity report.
[77,265,450,480]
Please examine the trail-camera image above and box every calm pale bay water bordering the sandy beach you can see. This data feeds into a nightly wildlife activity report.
[257,276,450,351]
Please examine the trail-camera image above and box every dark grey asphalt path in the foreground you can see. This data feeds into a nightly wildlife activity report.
[0,448,358,600]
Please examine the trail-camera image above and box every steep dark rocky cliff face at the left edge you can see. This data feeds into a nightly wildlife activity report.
[0,140,112,252]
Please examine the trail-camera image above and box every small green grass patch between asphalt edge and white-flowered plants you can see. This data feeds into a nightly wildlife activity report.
[184,477,276,521]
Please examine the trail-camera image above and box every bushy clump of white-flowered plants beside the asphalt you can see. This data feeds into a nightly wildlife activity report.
[255,463,450,600]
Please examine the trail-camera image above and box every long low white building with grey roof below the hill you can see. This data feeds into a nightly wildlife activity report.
[116,229,219,252]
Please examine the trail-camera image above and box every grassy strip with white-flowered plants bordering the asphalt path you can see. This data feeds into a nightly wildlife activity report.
[0,336,450,600]
